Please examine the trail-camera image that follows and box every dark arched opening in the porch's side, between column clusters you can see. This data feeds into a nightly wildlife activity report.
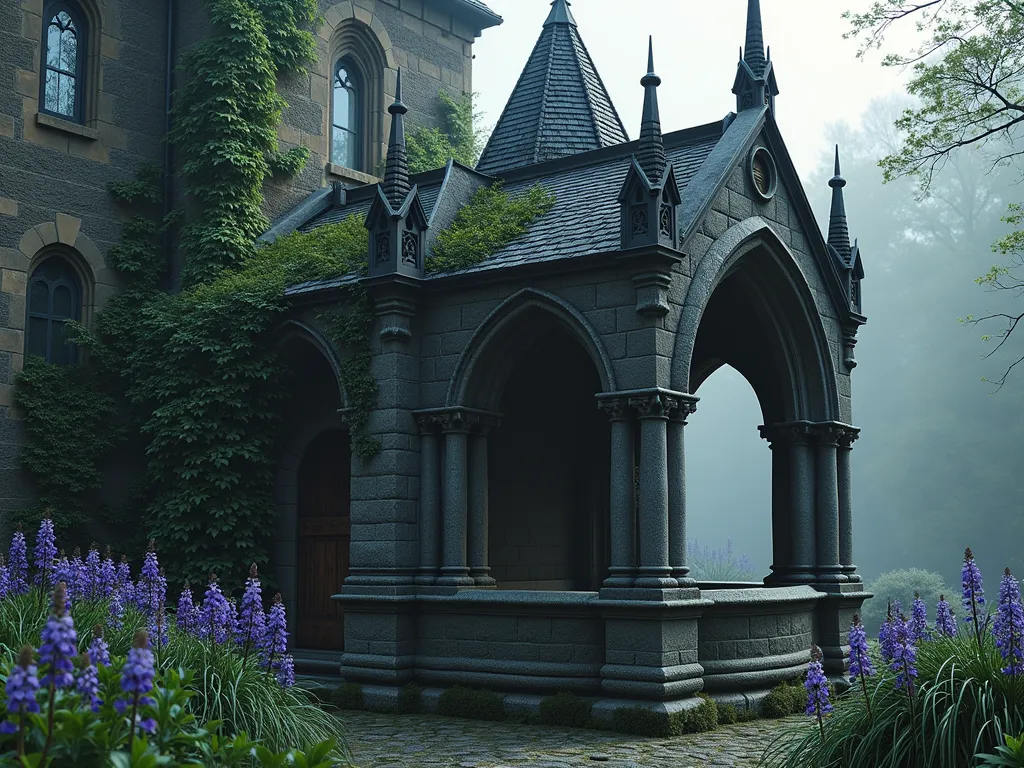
[488,329,609,590]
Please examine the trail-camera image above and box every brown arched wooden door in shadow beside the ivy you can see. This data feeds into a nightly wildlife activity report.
[296,431,351,650]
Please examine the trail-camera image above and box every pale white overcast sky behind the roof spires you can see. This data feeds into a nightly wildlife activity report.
[473,0,902,176]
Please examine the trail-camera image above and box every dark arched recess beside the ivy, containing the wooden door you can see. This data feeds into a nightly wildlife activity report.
[272,325,351,650]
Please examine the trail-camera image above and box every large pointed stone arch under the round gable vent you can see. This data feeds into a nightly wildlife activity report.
[672,217,840,424]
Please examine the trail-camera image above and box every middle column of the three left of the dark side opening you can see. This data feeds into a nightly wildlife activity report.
[437,413,473,587]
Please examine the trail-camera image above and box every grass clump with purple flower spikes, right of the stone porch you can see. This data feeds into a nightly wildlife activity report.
[763,550,1024,768]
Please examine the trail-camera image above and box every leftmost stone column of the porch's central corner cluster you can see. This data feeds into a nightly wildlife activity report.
[598,398,637,588]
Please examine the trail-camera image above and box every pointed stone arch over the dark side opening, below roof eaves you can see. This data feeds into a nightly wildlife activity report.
[446,288,616,411]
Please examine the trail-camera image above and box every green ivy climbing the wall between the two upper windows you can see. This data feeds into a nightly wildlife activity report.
[170,0,317,285]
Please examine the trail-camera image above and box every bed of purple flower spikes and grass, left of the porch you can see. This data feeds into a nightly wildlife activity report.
[0,522,346,768]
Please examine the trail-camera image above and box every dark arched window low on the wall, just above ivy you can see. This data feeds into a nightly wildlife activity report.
[25,256,82,366]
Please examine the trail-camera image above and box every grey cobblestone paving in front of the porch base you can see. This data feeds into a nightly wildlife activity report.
[341,712,800,768]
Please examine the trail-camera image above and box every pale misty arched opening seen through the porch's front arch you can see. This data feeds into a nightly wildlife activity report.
[686,365,772,582]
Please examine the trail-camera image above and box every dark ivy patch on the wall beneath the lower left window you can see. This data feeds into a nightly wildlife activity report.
[14,356,122,528]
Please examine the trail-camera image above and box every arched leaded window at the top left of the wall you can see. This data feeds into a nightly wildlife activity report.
[40,4,85,122]
